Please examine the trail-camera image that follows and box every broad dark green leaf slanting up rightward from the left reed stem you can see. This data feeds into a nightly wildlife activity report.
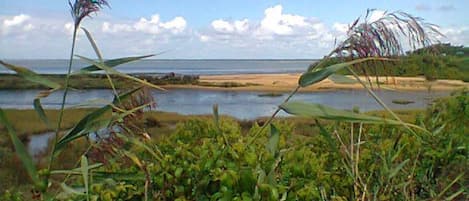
[54,87,141,153]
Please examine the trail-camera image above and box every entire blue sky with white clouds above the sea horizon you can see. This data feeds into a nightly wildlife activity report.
[0,0,469,59]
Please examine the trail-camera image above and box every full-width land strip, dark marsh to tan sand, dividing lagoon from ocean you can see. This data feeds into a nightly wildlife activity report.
[0,73,469,92]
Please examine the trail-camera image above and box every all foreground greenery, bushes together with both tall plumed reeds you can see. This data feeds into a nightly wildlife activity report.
[0,0,469,200]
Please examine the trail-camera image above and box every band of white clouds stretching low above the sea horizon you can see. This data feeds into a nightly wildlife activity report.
[0,5,469,58]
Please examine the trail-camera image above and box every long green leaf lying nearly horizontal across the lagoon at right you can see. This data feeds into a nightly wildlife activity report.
[280,102,415,126]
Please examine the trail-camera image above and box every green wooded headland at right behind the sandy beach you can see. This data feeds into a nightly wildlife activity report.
[310,44,469,82]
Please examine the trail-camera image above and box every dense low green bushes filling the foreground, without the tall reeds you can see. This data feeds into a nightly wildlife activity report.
[1,90,469,200]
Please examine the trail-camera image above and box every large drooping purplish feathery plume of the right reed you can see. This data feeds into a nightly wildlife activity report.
[332,9,443,85]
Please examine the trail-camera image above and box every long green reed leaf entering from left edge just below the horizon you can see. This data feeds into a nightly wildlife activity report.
[0,60,60,89]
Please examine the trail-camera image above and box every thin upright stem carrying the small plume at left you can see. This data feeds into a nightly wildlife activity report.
[48,25,78,170]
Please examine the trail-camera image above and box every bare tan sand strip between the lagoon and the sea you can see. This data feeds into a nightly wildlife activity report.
[162,73,469,92]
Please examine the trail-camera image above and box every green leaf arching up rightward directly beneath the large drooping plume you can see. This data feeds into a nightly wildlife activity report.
[298,57,390,87]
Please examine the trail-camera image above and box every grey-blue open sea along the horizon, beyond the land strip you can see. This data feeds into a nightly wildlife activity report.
[0,59,317,75]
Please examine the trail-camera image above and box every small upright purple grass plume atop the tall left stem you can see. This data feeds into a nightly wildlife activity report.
[68,0,109,27]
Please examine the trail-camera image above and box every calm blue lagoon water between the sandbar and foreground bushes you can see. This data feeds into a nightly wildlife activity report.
[0,89,449,120]
